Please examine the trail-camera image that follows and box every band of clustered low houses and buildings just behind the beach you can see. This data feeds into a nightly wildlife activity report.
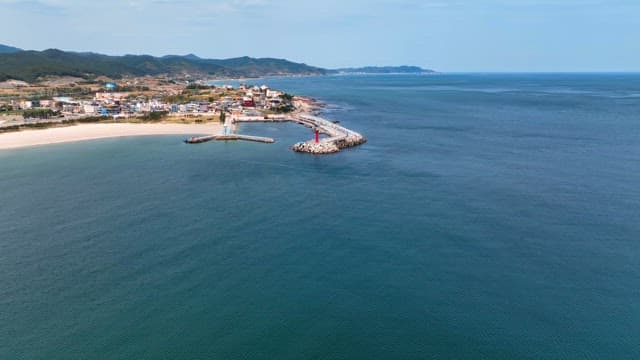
[5,84,287,117]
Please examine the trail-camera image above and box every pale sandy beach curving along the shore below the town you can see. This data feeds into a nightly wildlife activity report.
[0,123,222,149]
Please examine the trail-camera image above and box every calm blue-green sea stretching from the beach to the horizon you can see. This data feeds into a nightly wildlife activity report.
[0,73,640,359]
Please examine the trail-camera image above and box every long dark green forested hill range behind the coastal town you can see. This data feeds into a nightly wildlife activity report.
[0,49,327,82]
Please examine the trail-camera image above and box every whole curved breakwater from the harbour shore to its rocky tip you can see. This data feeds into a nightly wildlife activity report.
[233,114,367,154]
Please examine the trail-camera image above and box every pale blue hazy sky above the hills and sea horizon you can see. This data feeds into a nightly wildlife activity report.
[0,0,640,72]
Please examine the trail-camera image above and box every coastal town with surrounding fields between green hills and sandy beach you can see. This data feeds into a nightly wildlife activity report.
[0,79,293,128]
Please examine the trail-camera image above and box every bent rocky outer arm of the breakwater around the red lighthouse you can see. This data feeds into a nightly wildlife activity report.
[291,114,367,154]
